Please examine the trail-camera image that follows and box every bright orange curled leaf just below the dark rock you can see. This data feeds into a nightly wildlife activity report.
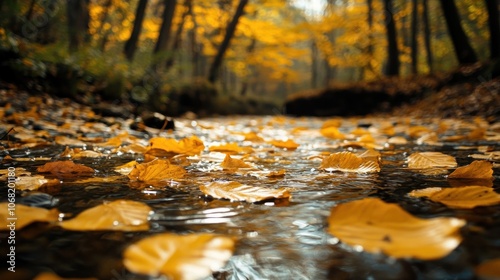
[146,136,205,156]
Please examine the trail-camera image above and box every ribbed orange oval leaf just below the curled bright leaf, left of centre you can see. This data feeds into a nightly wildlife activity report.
[128,159,186,182]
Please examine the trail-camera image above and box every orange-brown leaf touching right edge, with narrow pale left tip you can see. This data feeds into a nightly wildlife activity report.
[409,186,500,209]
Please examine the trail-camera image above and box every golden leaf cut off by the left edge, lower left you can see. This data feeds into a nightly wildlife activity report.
[0,202,59,230]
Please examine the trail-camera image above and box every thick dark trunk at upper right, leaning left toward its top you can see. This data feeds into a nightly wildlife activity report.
[439,0,478,64]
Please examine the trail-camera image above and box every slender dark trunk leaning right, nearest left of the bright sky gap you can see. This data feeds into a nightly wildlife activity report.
[208,0,248,83]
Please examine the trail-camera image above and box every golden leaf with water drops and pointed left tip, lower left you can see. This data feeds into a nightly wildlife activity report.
[60,200,152,231]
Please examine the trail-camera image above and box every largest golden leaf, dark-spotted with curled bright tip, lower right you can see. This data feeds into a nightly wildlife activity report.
[328,198,465,260]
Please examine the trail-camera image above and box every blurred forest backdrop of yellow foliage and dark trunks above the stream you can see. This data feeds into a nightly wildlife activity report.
[0,0,500,115]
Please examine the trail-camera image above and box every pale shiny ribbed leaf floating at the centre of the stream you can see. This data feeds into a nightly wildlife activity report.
[200,181,291,203]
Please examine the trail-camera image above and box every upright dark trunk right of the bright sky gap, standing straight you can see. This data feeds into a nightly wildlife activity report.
[384,0,400,76]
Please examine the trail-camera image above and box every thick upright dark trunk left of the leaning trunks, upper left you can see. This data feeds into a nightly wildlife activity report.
[66,0,90,51]
